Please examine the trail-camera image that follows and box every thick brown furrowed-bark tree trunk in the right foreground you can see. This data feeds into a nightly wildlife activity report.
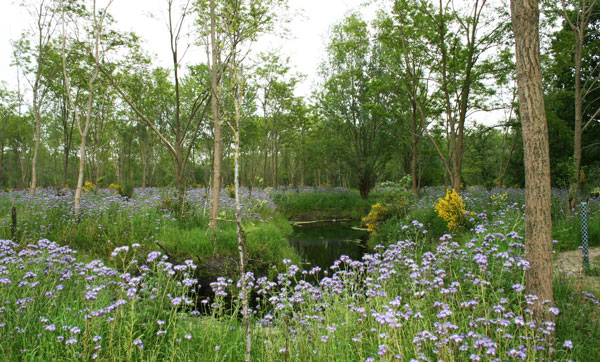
[511,0,553,321]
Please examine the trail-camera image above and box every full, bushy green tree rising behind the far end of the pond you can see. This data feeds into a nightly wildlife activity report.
[319,14,391,199]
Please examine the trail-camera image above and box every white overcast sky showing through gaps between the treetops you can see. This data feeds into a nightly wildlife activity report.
[0,0,380,95]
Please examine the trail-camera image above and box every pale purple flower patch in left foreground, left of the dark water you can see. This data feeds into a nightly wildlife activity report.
[0,240,198,360]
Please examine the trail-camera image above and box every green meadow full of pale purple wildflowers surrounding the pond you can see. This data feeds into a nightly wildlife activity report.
[0,188,600,361]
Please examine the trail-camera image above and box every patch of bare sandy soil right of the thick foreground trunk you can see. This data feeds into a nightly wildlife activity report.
[554,247,600,290]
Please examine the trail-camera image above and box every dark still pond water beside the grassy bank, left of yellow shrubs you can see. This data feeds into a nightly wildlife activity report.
[289,222,369,270]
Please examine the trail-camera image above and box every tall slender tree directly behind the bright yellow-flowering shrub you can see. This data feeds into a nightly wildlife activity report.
[434,0,508,191]
